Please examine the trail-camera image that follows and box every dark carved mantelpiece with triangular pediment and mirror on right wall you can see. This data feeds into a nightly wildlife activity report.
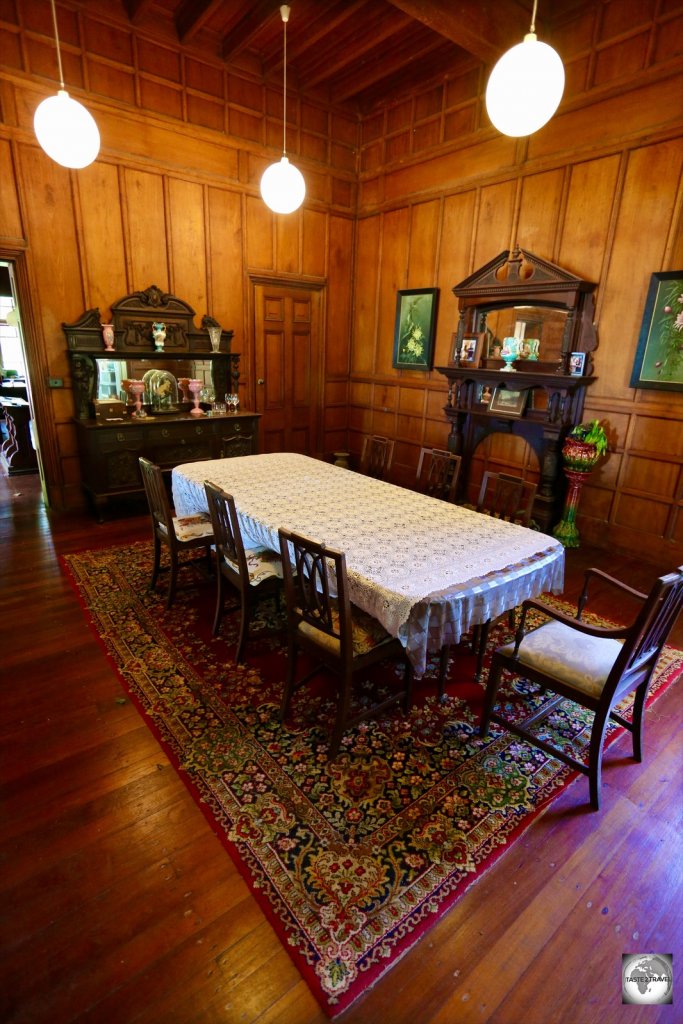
[436,249,597,530]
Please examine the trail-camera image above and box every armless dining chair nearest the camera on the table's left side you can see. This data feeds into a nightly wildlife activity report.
[279,529,413,759]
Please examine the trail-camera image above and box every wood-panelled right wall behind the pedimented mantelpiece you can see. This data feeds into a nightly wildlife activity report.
[349,0,683,565]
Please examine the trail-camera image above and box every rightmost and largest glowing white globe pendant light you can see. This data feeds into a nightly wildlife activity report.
[486,0,564,136]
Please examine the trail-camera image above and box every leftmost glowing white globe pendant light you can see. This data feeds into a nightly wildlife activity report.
[33,0,99,169]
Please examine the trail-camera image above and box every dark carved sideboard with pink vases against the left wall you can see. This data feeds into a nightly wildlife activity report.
[62,285,259,518]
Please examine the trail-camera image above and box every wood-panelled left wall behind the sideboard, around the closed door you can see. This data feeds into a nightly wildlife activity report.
[0,0,358,507]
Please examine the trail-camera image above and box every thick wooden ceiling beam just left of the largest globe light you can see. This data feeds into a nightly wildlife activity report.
[382,0,530,63]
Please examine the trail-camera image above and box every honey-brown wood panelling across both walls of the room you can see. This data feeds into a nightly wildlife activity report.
[0,0,683,563]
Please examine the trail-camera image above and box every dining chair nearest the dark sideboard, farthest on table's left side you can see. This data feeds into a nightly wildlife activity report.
[138,457,213,608]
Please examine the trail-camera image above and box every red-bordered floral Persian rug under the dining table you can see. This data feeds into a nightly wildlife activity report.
[62,543,683,1017]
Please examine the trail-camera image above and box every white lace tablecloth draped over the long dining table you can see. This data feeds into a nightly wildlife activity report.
[172,453,564,676]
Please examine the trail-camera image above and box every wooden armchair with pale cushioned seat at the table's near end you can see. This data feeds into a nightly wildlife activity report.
[480,566,683,810]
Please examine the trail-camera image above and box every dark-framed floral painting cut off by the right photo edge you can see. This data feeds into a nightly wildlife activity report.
[631,270,683,391]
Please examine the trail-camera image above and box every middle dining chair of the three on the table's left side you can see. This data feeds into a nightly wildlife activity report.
[204,480,283,664]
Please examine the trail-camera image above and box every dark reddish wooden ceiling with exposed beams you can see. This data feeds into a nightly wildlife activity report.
[124,0,548,114]
